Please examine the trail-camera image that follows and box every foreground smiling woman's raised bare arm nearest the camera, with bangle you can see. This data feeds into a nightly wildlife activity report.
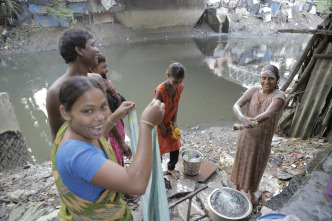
[91,101,165,195]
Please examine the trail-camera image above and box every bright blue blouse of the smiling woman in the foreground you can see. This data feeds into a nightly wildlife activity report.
[55,139,107,202]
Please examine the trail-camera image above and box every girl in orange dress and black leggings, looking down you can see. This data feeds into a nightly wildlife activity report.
[154,62,185,179]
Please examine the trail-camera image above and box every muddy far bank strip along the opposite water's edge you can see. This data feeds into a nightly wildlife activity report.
[0,12,323,56]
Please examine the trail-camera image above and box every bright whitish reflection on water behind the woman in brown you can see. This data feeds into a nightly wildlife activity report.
[195,36,308,87]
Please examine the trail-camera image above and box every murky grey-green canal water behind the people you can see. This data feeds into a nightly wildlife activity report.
[0,35,309,163]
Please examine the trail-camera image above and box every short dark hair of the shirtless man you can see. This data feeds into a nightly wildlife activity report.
[59,29,93,63]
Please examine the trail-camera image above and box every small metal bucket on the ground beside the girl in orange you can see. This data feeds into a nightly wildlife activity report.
[181,150,203,176]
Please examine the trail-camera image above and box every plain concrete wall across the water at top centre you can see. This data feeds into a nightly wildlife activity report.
[115,0,206,30]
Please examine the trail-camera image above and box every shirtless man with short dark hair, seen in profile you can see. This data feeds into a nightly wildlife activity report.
[46,29,134,158]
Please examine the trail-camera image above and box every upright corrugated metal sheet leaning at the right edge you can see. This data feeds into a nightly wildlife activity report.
[290,43,332,139]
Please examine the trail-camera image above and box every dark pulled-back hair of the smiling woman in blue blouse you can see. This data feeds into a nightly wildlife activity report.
[59,76,105,111]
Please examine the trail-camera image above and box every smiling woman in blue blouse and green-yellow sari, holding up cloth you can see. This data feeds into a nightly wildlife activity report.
[52,76,164,220]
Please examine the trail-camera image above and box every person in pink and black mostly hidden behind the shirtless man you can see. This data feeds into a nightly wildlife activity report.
[90,53,132,166]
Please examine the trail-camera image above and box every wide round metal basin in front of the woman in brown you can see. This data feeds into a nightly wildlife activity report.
[208,187,252,221]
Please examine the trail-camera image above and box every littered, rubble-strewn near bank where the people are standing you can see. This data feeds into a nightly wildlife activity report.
[0,127,328,220]
